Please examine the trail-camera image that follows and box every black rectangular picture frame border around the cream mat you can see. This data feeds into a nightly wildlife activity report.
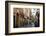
[5,1,45,35]
